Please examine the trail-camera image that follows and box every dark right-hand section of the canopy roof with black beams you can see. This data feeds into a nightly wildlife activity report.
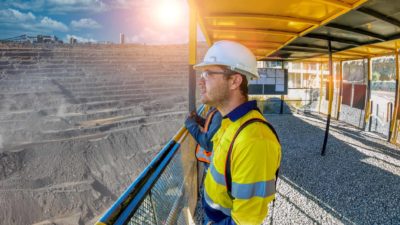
[270,0,400,60]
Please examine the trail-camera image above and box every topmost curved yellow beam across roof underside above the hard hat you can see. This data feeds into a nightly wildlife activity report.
[206,13,319,25]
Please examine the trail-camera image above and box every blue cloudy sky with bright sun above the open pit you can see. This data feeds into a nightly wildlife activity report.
[0,0,199,44]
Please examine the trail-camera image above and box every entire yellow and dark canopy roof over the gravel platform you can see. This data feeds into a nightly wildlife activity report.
[189,0,400,61]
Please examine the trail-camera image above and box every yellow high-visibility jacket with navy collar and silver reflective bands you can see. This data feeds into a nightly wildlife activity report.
[203,101,281,224]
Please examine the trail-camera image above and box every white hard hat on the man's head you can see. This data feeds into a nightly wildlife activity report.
[193,41,260,80]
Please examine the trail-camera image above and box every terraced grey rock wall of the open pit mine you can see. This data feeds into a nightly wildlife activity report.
[0,45,205,225]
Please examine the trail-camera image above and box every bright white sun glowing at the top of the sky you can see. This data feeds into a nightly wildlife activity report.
[156,0,183,26]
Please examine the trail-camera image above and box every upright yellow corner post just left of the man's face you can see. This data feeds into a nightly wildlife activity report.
[188,4,197,112]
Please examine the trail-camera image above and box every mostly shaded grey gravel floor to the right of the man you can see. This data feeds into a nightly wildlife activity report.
[266,115,400,224]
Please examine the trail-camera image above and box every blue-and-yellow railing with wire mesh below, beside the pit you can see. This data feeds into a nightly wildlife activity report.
[96,107,204,225]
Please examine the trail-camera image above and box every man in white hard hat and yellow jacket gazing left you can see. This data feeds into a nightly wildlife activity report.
[194,41,281,224]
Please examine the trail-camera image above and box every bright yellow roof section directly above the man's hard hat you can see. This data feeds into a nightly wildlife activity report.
[189,0,369,57]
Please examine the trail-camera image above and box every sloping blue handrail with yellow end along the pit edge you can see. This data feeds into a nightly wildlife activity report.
[95,105,204,225]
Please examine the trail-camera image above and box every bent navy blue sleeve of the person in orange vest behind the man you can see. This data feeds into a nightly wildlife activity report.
[185,112,222,151]
